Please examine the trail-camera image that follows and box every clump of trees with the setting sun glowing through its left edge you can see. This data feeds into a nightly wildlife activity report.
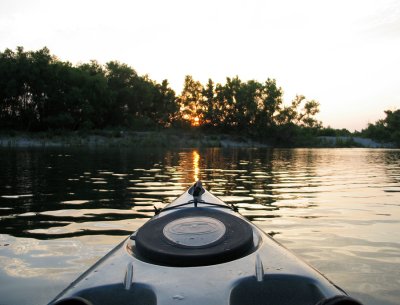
[177,76,321,142]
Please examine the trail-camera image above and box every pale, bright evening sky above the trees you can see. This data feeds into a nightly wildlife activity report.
[0,0,400,131]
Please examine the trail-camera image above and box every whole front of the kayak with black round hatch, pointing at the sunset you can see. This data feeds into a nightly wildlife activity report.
[49,181,361,305]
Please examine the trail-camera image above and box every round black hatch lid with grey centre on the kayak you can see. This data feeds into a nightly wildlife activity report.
[135,207,254,266]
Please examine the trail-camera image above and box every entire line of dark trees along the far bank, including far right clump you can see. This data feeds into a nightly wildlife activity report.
[5,47,400,145]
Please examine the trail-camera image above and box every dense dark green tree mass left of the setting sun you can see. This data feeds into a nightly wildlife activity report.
[0,47,177,131]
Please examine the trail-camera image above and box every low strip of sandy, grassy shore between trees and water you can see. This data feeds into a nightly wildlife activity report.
[0,130,395,148]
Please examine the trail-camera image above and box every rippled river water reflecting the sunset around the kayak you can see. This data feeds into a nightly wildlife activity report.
[0,148,400,305]
